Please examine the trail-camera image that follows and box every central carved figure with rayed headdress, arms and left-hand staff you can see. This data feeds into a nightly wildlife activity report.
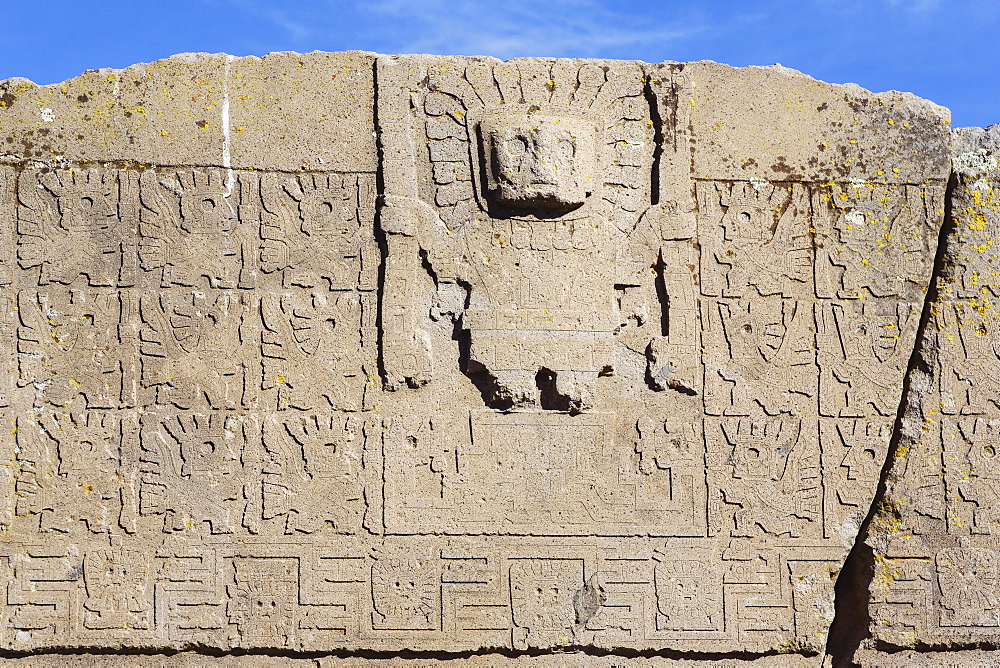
[379,58,684,412]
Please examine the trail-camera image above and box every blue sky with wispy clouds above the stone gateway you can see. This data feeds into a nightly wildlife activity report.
[0,0,1000,127]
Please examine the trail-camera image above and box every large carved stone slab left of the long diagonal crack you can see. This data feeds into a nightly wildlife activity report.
[0,53,951,665]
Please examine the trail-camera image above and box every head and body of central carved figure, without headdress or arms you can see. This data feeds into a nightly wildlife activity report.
[459,108,618,408]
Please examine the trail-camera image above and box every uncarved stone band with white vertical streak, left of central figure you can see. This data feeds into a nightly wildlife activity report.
[0,51,377,172]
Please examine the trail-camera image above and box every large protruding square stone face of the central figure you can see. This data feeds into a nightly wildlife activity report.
[482,114,597,212]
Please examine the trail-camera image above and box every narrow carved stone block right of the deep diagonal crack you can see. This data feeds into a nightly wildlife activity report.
[868,126,1000,647]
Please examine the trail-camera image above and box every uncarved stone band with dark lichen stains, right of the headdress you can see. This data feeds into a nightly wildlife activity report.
[685,62,950,183]
